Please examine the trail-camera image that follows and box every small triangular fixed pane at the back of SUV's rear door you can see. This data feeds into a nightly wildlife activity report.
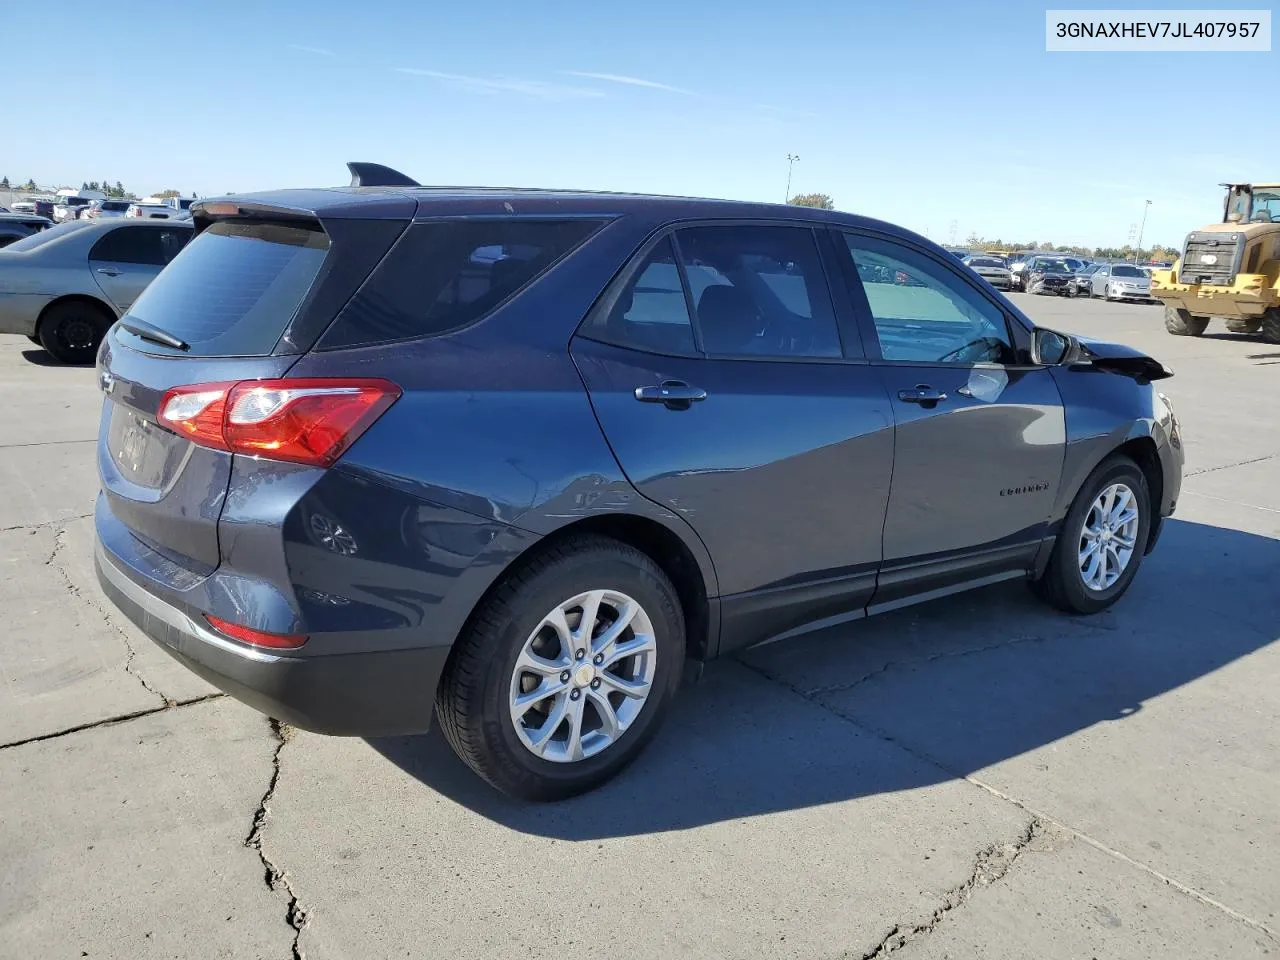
[582,237,698,357]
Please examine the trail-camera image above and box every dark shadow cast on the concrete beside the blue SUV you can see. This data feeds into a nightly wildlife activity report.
[370,520,1280,840]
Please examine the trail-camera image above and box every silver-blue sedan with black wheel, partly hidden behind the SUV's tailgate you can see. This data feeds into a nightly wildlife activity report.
[0,220,192,364]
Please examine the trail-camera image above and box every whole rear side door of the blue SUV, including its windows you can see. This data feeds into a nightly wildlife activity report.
[572,224,892,650]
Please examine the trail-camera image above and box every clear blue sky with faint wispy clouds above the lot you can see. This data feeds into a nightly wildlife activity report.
[0,0,1280,244]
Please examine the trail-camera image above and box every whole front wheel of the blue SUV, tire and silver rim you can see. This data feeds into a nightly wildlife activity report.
[1033,453,1152,613]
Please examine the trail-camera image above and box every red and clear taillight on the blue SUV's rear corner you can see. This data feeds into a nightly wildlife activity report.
[156,379,401,467]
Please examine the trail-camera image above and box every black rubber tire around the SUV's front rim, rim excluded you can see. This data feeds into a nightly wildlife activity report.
[1032,453,1152,613]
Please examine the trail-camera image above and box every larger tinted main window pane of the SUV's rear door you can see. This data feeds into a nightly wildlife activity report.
[676,224,841,358]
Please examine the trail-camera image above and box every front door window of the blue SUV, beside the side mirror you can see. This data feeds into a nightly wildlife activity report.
[845,234,1012,364]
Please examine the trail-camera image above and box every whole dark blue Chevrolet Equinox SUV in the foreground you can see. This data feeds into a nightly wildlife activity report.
[95,165,1183,800]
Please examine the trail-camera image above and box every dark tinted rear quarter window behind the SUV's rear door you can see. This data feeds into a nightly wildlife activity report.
[320,219,602,349]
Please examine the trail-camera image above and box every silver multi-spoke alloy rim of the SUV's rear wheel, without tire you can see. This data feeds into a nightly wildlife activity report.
[508,590,658,763]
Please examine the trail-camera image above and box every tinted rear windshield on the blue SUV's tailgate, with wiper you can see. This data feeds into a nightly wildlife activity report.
[119,220,329,357]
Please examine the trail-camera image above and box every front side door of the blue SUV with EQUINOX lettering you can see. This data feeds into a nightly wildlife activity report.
[841,233,1066,603]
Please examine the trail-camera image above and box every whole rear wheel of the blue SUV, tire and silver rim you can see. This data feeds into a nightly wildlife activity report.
[435,535,685,801]
